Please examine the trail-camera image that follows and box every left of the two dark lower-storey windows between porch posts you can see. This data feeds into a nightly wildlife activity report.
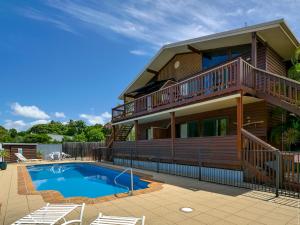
[176,121,199,138]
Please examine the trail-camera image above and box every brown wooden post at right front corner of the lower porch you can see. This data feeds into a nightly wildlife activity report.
[236,92,243,160]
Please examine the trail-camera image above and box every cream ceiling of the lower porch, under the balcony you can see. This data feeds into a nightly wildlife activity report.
[115,94,262,124]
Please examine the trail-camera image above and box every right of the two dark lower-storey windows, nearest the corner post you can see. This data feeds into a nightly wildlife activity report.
[202,118,228,136]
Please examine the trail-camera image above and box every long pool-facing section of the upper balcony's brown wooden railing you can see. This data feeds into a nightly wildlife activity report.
[112,59,241,122]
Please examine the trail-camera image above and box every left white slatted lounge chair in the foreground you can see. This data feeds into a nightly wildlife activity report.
[12,203,85,225]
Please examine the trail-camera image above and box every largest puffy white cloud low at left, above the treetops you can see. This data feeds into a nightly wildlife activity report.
[11,102,50,119]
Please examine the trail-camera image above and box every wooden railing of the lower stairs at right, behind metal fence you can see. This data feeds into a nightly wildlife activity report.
[242,129,300,197]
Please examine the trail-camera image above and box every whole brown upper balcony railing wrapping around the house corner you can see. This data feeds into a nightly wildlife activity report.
[112,58,300,123]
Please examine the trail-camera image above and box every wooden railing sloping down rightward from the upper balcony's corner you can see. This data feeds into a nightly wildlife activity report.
[241,60,300,116]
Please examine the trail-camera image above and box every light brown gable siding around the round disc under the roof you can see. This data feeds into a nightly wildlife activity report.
[158,53,202,81]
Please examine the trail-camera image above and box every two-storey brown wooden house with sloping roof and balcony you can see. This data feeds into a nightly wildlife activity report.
[109,20,300,171]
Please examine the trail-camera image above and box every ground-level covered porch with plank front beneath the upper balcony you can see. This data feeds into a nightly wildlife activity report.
[112,93,267,169]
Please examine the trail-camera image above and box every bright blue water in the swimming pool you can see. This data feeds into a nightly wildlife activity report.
[27,163,149,198]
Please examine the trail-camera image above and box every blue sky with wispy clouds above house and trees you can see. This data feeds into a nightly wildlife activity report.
[0,0,300,130]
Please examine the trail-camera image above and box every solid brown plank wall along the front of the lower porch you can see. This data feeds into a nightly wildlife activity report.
[113,135,240,168]
